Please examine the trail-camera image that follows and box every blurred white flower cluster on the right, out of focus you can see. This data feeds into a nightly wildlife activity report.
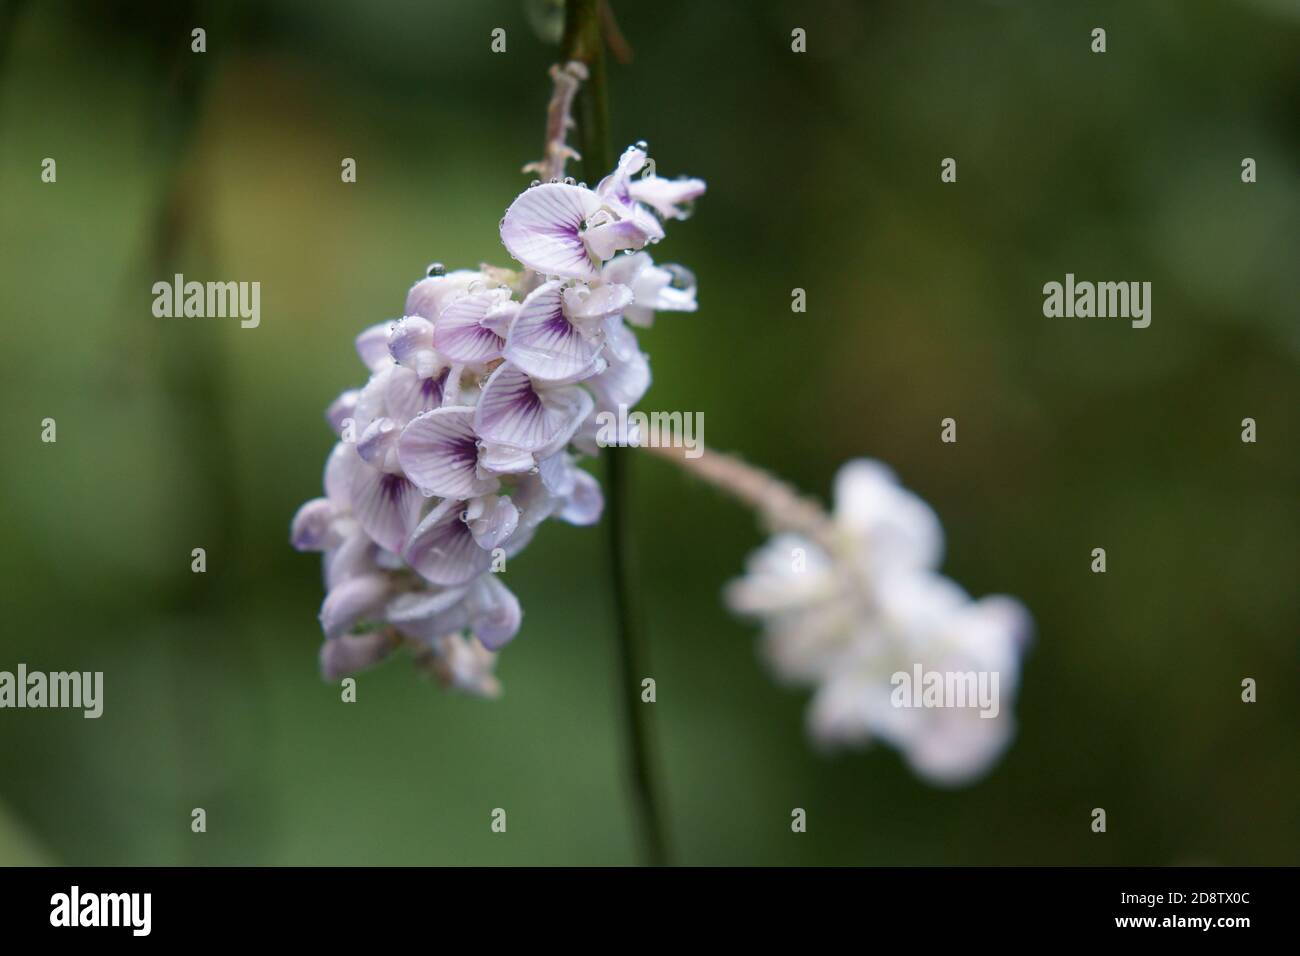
[714,459,1031,784]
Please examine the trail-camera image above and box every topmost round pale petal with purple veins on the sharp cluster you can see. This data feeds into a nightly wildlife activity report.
[501,182,602,278]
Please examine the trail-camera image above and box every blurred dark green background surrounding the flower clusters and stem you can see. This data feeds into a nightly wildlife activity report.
[0,0,1300,864]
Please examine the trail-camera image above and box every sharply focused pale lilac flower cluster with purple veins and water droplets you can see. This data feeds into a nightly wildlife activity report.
[291,141,705,695]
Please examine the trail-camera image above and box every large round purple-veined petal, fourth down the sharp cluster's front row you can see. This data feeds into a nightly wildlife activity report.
[398,406,499,498]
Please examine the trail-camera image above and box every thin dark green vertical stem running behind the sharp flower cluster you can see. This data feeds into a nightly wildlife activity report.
[563,0,668,866]
